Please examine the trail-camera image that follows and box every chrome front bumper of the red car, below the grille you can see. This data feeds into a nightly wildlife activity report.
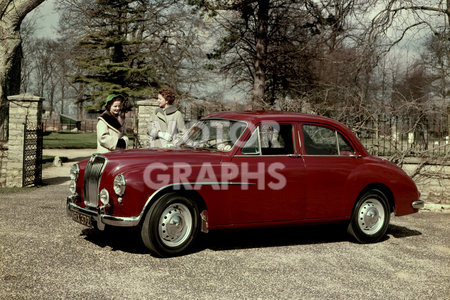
[66,196,141,230]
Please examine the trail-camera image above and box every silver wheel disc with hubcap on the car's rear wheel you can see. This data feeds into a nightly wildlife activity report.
[358,199,385,235]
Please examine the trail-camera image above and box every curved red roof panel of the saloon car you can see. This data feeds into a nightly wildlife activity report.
[203,110,342,126]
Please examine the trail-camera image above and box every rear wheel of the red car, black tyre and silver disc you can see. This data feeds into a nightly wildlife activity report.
[348,189,390,243]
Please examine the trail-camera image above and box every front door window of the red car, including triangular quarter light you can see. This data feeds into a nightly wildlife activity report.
[241,124,294,155]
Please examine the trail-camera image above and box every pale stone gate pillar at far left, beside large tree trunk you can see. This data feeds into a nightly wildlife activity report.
[6,94,44,187]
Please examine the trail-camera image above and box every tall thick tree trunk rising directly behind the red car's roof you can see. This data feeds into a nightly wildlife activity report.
[252,0,269,109]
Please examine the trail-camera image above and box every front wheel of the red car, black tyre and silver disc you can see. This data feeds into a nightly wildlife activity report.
[141,193,199,257]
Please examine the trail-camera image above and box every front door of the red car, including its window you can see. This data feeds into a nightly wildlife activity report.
[229,123,305,224]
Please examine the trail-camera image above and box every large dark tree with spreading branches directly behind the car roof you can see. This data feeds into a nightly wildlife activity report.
[190,0,380,108]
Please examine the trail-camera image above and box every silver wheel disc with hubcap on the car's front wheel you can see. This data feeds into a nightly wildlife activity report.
[158,203,192,247]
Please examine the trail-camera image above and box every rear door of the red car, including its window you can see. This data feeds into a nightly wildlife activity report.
[301,124,362,219]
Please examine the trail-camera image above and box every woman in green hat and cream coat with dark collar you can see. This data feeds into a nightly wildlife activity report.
[97,94,128,153]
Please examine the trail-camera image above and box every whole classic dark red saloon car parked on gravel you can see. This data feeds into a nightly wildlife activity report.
[67,112,423,256]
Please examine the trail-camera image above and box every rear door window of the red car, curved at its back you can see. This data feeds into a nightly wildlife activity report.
[303,125,354,155]
